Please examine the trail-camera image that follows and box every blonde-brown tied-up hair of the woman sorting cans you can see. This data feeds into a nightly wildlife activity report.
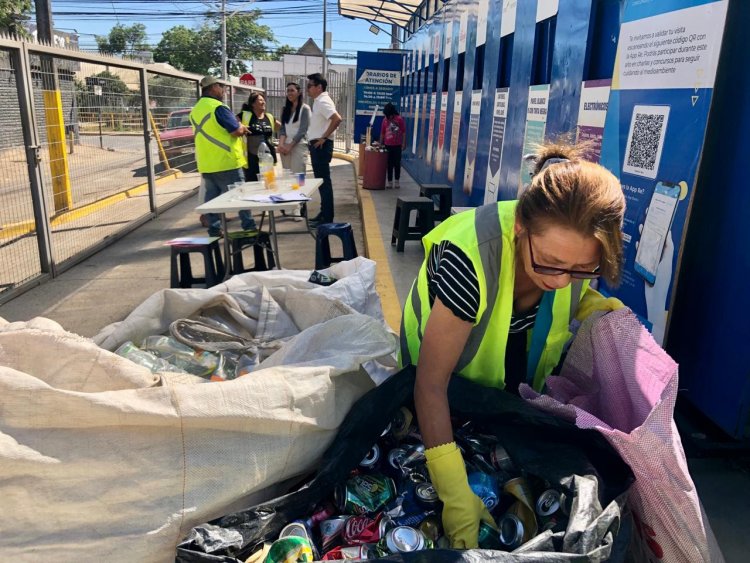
[516,140,625,286]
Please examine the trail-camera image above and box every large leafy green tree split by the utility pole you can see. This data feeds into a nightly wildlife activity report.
[154,10,282,75]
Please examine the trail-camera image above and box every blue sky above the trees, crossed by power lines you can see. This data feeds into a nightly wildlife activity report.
[48,0,390,64]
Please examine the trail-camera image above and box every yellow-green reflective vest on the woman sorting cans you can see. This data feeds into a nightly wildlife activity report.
[399,201,598,391]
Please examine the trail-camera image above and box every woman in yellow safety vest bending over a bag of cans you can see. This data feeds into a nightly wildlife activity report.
[401,144,625,549]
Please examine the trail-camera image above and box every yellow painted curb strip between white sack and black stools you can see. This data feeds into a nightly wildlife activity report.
[357,178,401,333]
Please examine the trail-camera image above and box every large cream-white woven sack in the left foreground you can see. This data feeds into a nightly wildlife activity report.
[0,313,395,562]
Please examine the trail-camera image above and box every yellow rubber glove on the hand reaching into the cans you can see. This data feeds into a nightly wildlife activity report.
[425,442,497,549]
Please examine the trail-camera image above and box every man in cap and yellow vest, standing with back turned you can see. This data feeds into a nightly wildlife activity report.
[190,76,257,236]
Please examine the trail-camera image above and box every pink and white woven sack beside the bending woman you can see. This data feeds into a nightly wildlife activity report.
[519,309,724,563]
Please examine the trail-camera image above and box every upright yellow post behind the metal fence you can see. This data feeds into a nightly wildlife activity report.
[42,90,73,213]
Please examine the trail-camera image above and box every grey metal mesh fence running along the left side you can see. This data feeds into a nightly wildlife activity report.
[0,37,270,303]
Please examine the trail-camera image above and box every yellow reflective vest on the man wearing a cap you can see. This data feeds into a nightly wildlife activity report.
[190,96,247,174]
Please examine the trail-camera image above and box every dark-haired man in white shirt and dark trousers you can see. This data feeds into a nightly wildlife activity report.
[307,72,341,228]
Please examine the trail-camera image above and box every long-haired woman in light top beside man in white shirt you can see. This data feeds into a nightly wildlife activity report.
[278,82,310,173]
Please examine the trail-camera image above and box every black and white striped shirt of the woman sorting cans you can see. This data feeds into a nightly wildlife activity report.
[427,240,539,334]
